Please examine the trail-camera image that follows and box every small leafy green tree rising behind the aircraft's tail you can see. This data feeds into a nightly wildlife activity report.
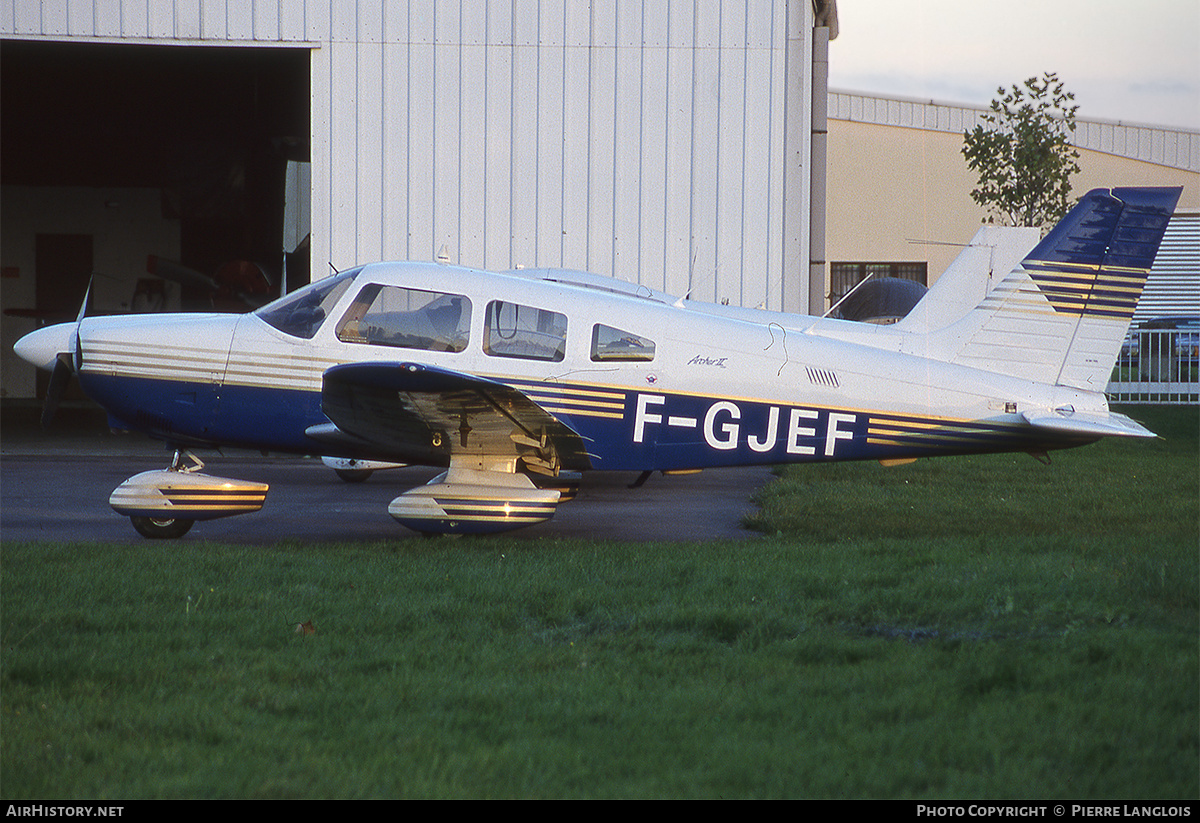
[962,72,1079,227]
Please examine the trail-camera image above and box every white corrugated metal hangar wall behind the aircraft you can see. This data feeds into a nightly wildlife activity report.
[0,0,814,311]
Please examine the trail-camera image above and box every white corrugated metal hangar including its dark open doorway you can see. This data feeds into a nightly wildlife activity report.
[0,0,836,397]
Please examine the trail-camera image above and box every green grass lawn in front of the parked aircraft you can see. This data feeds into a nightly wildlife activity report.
[0,408,1200,800]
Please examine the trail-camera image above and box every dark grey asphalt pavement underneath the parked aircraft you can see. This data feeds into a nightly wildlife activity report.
[0,407,772,545]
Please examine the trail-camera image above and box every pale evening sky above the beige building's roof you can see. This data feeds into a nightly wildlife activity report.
[829,0,1200,131]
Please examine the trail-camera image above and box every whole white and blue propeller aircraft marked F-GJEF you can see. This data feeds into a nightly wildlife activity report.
[16,188,1181,537]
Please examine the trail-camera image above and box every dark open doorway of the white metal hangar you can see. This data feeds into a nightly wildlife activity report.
[0,41,310,331]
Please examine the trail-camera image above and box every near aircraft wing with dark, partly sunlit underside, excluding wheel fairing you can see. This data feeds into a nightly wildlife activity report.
[308,362,592,474]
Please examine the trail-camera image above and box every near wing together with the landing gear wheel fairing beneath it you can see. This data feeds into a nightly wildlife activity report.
[308,362,592,533]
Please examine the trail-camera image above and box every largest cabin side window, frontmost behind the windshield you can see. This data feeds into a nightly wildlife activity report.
[337,283,470,352]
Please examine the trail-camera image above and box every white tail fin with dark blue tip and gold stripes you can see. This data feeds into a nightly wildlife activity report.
[935,188,1182,391]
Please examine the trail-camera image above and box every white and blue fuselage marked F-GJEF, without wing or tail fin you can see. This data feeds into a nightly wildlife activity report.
[48,263,1106,470]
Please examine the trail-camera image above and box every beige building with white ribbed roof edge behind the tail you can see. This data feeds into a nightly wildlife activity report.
[826,90,1200,322]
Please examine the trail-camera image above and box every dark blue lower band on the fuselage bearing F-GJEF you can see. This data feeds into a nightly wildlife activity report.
[80,372,1087,471]
